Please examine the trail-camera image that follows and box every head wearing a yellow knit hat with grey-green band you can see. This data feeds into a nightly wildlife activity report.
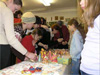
[21,12,36,29]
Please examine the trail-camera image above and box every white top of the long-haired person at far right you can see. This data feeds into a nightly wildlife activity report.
[80,14,100,75]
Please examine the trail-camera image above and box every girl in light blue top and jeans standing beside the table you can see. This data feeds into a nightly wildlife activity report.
[68,19,83,75]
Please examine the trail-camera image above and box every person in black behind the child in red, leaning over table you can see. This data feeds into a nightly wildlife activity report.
[27,16,50,55]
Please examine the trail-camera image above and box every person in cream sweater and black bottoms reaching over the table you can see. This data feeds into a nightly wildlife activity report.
[0,0,36,69]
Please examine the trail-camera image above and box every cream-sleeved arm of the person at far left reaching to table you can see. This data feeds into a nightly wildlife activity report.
[2,9,27,55]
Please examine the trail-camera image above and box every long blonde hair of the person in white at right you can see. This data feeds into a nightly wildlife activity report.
[82,0,100,27]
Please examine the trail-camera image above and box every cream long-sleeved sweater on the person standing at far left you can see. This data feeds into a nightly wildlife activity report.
[0,1,27,55]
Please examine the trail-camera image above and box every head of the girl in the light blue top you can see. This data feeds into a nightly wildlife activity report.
[68,19,79,32]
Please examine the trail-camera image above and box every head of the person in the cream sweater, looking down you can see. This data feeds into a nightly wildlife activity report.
[6,0,22,13]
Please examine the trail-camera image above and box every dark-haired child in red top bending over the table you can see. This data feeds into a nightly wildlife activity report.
[17,28,42,63]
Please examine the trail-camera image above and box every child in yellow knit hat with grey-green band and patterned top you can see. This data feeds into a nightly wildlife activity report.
[14,12,36,38]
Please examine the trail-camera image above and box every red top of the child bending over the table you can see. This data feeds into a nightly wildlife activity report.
[17,35,35,63]
